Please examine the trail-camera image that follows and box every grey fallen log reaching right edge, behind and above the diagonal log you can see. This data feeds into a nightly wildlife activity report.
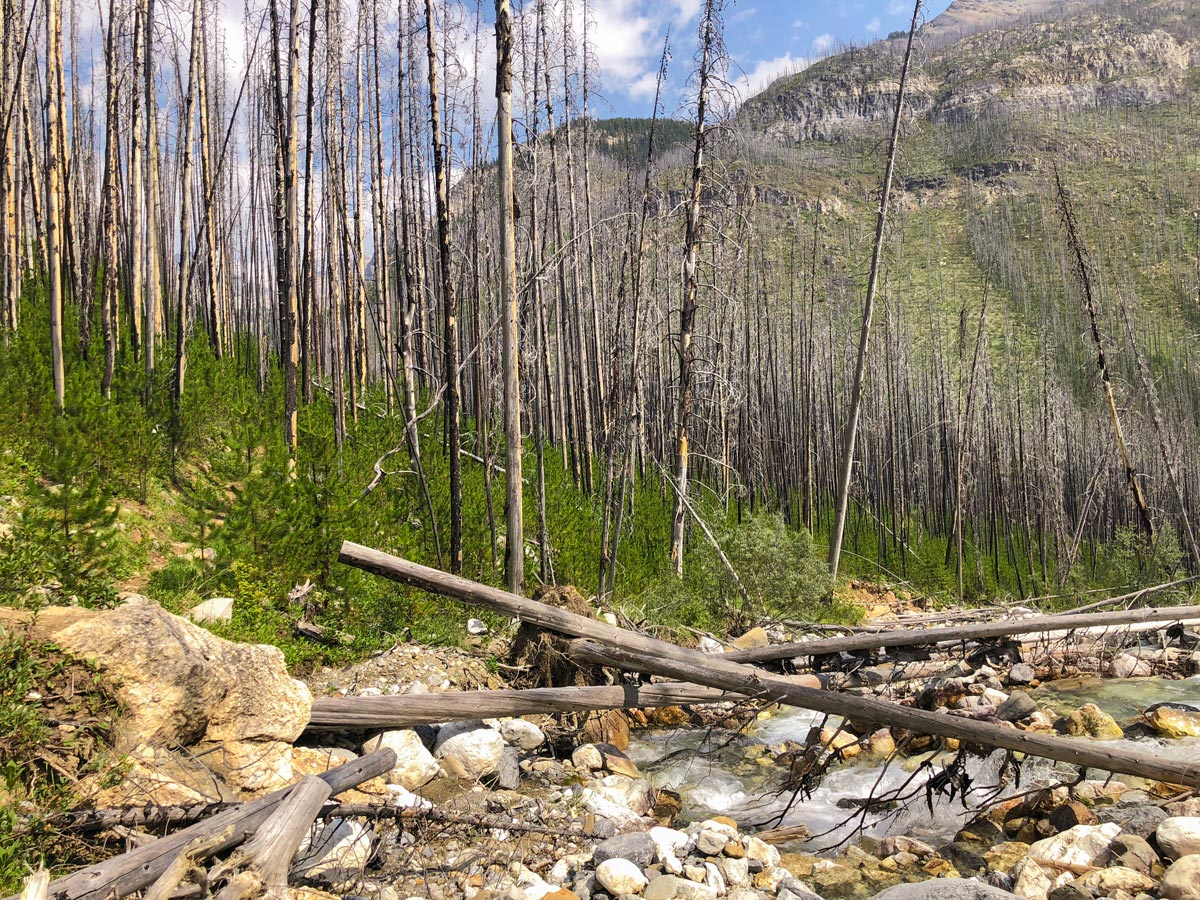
[715,606,1200,662]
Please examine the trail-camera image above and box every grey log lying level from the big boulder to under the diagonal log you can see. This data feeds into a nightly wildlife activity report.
[308,684,745,731]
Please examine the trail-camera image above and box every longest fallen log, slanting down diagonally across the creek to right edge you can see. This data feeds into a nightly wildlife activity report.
[340,541,1200,787]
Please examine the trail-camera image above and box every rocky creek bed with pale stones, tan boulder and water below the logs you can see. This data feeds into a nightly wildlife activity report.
[7,598,1200,900]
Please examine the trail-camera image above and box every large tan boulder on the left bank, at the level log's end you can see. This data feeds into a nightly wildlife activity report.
[54,598,312,751]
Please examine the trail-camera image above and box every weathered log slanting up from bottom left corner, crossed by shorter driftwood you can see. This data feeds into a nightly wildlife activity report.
[6,748,396,900]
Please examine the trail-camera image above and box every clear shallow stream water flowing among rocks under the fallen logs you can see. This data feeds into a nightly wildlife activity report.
[629,678,1200,851]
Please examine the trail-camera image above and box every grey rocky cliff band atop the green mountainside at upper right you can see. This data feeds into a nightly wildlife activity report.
[739,0,1200,144]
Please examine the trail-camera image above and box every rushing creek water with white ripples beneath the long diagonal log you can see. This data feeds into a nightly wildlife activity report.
[629,677,1200,852]
